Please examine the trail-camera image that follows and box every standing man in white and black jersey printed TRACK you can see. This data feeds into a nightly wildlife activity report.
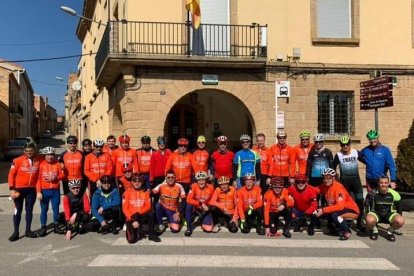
[332,135,365,230]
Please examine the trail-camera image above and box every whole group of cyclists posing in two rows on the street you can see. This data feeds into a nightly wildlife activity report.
[8,130,404,243]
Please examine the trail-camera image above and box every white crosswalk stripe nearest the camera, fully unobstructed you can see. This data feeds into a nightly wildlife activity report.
[88,254,400,270]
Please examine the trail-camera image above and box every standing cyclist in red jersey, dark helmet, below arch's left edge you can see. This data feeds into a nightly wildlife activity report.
[150,136,171,190]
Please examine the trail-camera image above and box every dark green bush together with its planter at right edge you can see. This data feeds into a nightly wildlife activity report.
[395,120,414,211]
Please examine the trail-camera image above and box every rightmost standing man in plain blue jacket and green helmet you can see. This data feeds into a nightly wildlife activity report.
[361,129,397,192]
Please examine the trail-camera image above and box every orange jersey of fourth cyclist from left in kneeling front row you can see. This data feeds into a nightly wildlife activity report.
[152,183,185,212]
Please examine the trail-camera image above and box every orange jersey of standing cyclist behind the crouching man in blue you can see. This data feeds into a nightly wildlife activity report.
[85,152,112,182]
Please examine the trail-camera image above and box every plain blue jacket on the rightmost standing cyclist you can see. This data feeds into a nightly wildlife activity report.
[361,144,397,182]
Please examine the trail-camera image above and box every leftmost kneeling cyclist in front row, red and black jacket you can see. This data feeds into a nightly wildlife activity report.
[63,179,91,241]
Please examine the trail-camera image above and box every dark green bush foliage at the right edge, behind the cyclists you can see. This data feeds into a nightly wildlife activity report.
[395,120,414,192]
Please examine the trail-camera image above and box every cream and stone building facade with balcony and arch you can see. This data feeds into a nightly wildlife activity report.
[77,0,414,156]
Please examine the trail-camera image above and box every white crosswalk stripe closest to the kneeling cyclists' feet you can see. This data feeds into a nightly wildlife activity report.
[112,237,369,248]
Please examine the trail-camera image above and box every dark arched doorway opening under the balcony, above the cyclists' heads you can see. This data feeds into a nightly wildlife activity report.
[164,89,255,150]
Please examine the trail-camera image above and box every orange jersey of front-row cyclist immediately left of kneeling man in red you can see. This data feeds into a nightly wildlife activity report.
[263,188,293,225]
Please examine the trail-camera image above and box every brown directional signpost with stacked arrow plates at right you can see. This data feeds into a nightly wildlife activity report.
[360,76,396,130]
